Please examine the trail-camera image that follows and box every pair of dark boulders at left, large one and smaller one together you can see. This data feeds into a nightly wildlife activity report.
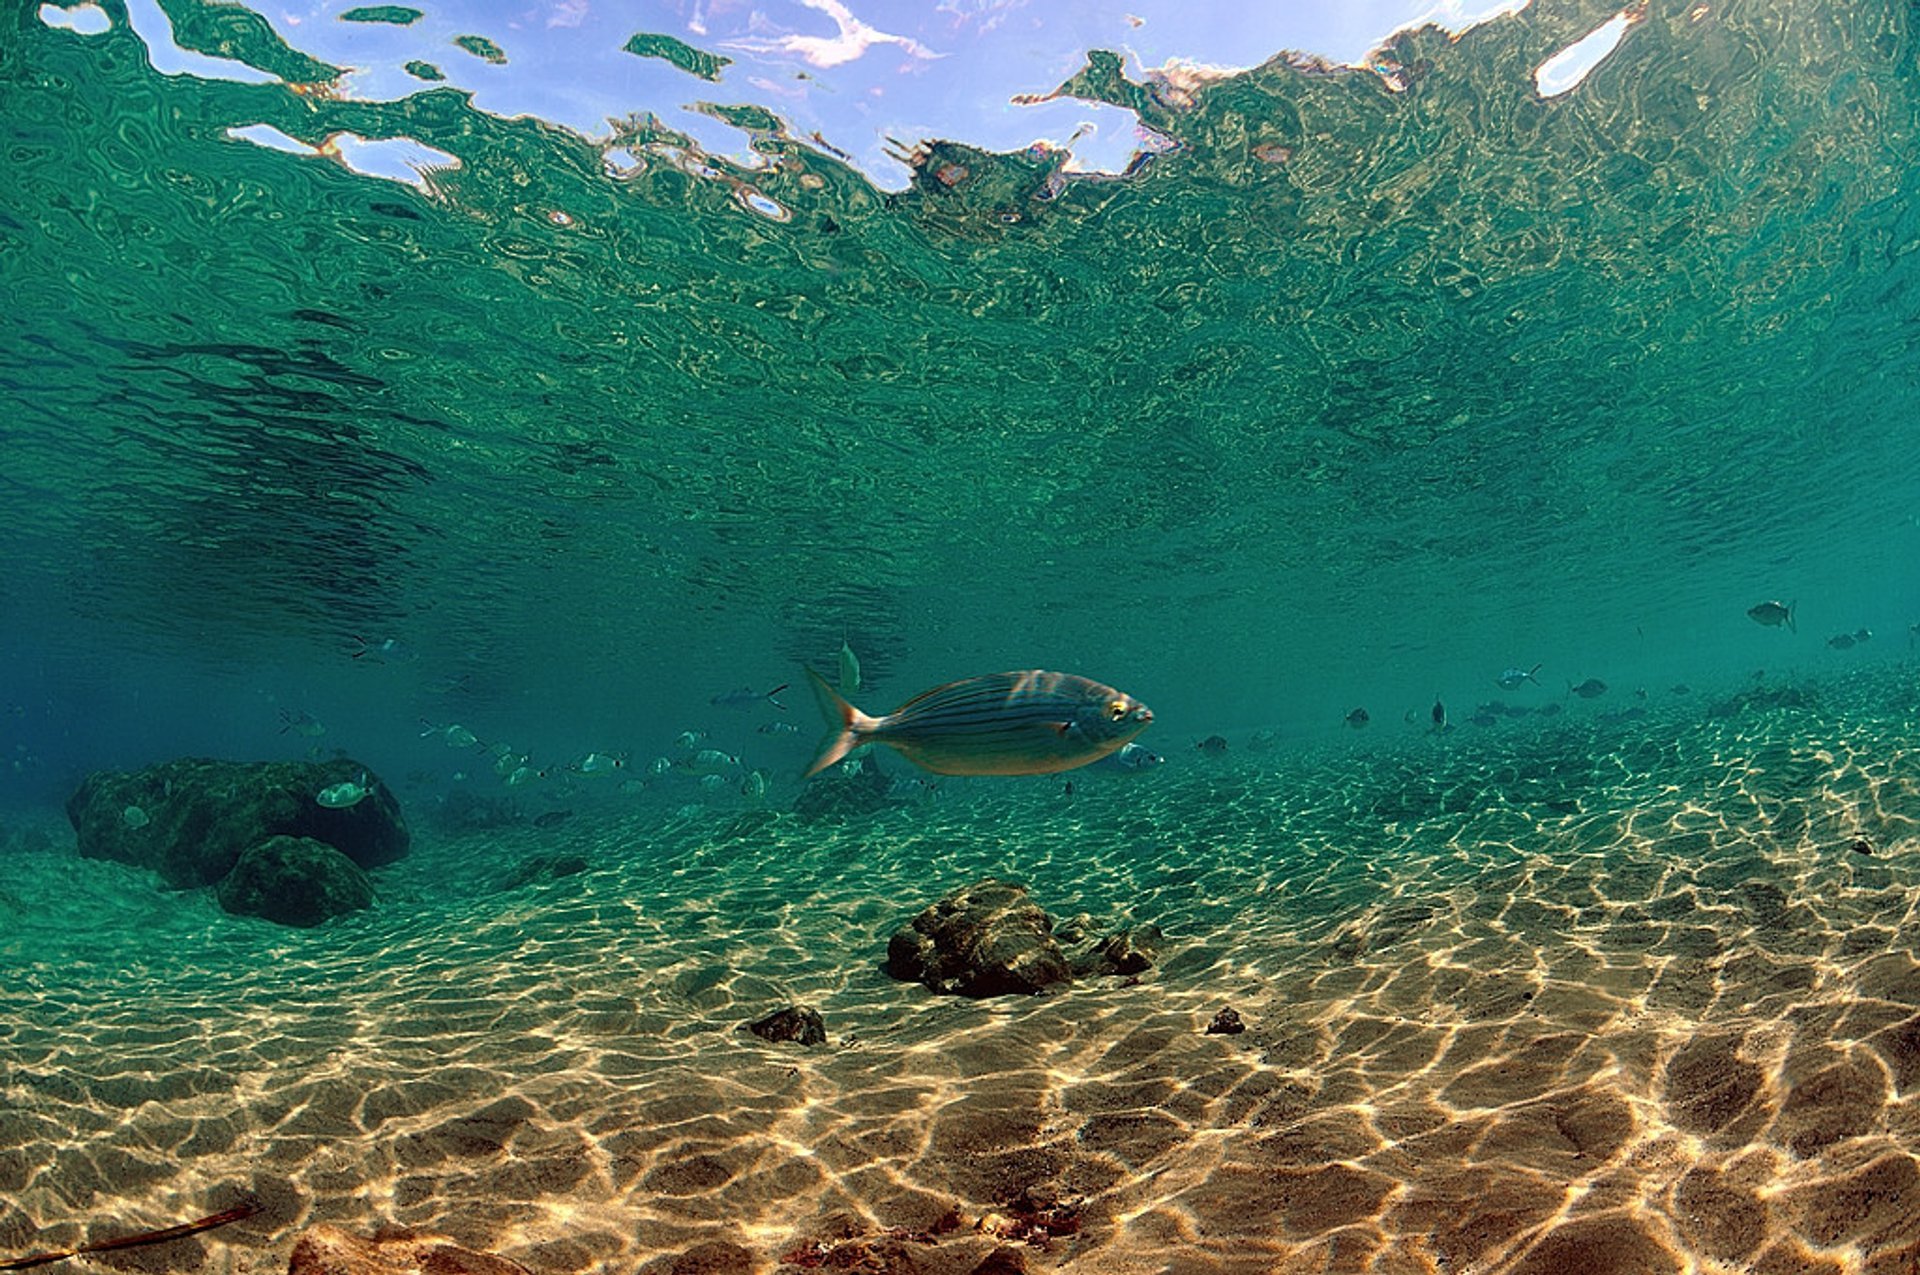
[67,758,409,926]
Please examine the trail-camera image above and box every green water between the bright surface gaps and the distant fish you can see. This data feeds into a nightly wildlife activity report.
[0,4,1920,748]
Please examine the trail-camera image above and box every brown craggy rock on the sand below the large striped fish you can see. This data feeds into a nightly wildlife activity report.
[887,878,1073,997]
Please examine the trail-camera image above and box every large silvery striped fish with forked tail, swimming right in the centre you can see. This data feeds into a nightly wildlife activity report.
[806,668,1154,776]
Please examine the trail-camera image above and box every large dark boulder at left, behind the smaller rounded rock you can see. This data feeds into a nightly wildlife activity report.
[67,758,409,889]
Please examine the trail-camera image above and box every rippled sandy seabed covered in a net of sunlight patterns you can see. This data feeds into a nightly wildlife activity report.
[0,676,1920,1275]
